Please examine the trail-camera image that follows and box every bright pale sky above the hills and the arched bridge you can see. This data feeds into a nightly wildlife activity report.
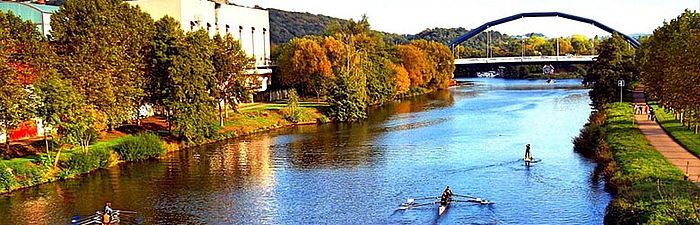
[229,0,700,37]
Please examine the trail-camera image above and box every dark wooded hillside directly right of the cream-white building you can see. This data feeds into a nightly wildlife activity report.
[268,8,345,44]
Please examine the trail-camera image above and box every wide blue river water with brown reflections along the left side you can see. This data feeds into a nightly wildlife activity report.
[0,79,611,224]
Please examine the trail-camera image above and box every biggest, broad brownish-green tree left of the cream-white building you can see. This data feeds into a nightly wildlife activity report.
[51,0,154,128]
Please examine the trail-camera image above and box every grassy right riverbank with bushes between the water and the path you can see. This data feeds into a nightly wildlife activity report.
[575,103,700,224]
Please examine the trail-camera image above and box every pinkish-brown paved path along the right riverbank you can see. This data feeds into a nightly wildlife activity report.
[632,88,700,186]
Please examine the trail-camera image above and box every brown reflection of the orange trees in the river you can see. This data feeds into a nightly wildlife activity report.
[276,90,454,169]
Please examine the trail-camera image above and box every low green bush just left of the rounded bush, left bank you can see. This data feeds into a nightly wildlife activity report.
[59,148,110,178]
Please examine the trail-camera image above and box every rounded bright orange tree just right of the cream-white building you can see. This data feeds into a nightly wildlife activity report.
[277,37,333,99]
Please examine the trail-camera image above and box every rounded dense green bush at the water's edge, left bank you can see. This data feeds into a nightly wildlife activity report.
[114,133,165,161]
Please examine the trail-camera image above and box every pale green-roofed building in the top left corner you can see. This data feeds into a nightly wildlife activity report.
[0,2,59,36]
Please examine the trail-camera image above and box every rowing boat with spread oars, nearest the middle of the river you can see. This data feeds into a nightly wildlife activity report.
[399,187,493,216]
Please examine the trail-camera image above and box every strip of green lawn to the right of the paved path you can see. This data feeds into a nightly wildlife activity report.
[651,105,700,155]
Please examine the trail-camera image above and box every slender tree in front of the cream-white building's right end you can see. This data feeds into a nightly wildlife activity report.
[212,34,254,126]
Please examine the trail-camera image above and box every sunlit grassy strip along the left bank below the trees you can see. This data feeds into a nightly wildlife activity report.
[0,103,328,193]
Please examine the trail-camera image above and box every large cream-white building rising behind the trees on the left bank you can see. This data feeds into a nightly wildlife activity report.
[127,0,272,92]
